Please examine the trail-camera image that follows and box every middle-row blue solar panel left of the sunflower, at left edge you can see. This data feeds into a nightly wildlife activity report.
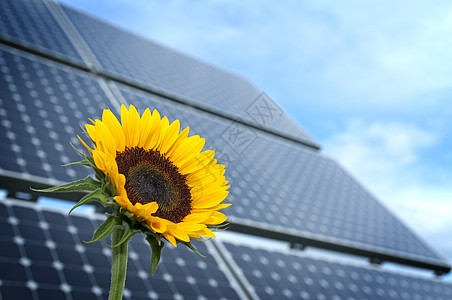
[0,46,111,181]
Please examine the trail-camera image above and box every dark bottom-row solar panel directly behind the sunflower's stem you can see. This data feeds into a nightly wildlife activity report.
[0,200,243,300]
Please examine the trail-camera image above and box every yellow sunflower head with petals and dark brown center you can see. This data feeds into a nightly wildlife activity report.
[78,105,230,247]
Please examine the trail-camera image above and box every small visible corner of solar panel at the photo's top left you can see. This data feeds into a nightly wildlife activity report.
[0,0,83,63]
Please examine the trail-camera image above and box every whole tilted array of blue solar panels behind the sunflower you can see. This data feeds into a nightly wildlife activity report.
[0,0,450,300]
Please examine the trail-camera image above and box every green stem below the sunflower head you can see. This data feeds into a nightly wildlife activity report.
[108,228,129,300]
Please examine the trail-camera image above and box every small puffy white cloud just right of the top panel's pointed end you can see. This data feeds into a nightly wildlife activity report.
[324,119,438,178]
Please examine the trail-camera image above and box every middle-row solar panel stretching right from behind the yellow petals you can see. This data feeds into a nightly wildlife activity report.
[114,87,445,265]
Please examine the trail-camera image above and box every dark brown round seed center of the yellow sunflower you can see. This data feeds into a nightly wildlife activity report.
[116,147,191,223]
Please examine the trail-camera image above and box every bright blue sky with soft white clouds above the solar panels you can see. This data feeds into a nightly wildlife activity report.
[60,0,452,268]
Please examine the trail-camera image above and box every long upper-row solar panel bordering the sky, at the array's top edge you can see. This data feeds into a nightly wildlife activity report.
[62,6,317,147]
